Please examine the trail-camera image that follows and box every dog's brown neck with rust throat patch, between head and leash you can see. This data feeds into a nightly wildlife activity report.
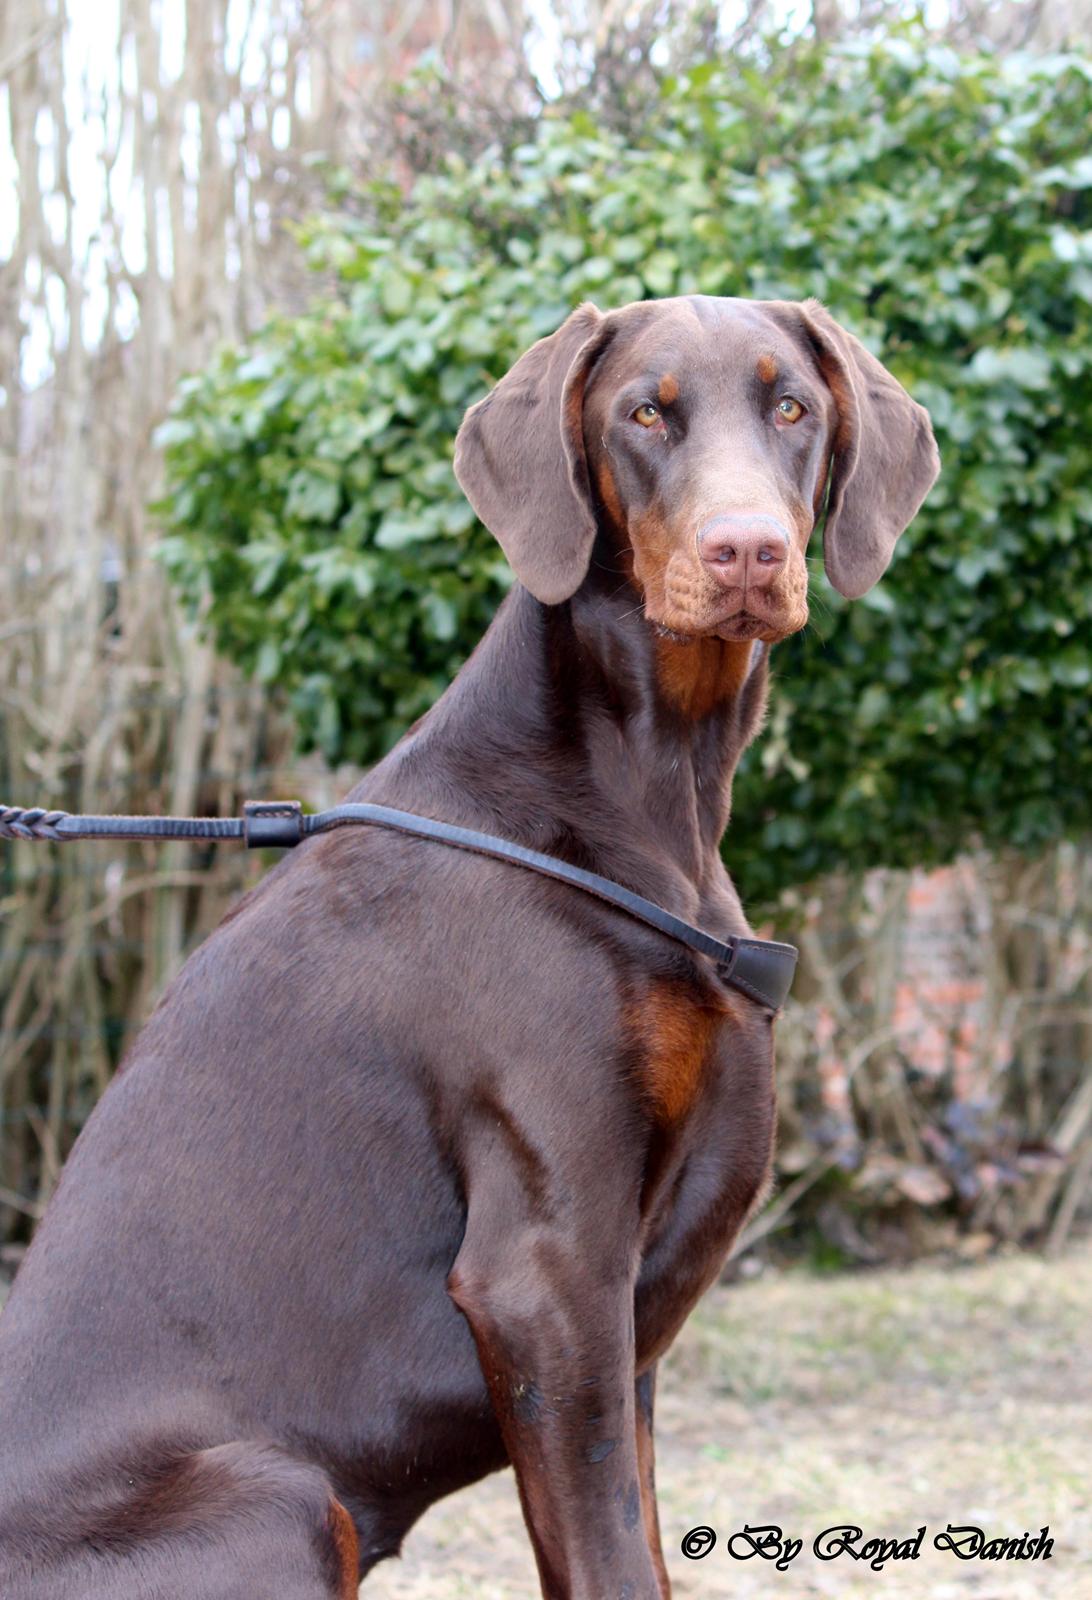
[362,570,767,893]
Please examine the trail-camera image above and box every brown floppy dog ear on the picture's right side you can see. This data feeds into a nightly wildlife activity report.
[790,301,940,600]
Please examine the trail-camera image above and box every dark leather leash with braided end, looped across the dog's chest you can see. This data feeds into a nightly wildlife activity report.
[0,800,797,1011]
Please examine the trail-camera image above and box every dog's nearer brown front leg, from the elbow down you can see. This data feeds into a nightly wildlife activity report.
[448,1205,663,1600]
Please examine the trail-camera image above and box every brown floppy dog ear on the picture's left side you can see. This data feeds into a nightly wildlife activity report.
[455,304,608,605]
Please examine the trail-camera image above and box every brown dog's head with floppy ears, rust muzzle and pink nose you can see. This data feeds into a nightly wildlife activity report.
[455,294,938,642]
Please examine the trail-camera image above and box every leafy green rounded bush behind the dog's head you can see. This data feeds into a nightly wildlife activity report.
[160,34,1092,901]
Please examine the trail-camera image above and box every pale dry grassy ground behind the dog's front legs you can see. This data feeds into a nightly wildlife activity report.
[360,1243,1092,1600]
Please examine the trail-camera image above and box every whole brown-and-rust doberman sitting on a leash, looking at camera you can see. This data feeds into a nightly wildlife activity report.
[0,296,937,1600]
